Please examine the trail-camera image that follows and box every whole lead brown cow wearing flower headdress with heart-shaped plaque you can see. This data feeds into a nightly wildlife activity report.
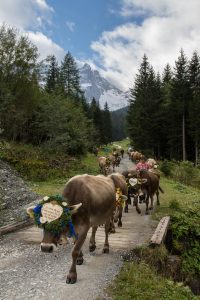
[27,174,126,283]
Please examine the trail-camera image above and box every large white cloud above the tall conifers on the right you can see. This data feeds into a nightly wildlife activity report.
[91,0,200,90]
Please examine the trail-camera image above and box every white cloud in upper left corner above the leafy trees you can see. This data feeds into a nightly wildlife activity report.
[0,0,64,60]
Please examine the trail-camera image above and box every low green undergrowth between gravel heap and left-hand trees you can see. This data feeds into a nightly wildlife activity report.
[0,144,81,181]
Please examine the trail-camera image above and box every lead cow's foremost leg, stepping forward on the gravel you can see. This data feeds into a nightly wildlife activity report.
[66,226,89,283]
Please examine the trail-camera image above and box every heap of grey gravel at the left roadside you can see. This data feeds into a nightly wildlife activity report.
[0,160,39,226]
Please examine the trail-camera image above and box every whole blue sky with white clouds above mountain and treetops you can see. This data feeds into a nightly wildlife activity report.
[0,0,200,91]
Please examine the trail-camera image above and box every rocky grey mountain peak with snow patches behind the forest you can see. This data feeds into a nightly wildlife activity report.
[79,64,128,111]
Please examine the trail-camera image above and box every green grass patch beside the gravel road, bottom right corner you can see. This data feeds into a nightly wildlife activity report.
[107,262,198,300]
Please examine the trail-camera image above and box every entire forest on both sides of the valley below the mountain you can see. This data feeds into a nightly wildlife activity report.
[0,25,200,165]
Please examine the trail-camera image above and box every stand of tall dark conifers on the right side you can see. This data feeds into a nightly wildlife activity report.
[127,49,200,165]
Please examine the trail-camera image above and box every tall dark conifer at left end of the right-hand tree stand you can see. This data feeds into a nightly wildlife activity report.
[127,55,161,156]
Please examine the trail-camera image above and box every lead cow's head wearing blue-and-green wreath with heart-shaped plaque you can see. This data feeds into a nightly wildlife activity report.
[27,197,82,253]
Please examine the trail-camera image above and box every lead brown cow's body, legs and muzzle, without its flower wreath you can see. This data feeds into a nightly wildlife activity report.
[27,174,120,283]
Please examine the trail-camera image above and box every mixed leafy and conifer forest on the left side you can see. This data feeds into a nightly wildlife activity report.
[0,25,112,155]
